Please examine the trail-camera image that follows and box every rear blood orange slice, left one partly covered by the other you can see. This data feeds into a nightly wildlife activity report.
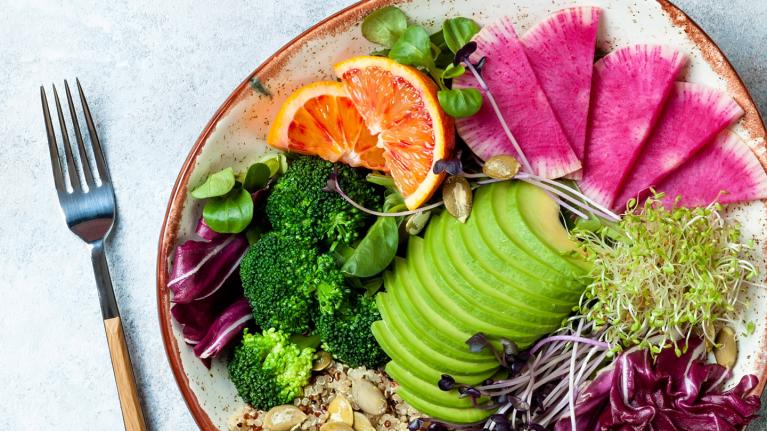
[266,81,388,171]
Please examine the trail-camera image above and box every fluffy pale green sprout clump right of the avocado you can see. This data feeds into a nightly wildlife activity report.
[574,194,757,355]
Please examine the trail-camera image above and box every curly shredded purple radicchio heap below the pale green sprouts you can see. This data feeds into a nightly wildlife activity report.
[554,340,761,431]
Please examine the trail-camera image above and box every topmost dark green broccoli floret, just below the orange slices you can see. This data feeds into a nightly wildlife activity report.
[266,156,381,250]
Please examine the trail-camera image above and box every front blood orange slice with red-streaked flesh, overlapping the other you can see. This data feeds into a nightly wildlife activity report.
[334,56,455,209]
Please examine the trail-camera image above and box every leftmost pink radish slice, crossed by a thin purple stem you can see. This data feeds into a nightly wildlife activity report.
[453,18,581,178]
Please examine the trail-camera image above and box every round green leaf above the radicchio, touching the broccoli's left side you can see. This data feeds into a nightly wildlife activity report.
[202,188,253,233]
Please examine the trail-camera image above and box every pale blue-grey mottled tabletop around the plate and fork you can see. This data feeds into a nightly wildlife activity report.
[0,0,767,431]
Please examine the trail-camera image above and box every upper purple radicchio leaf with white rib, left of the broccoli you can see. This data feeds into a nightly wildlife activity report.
[168,223,248,304]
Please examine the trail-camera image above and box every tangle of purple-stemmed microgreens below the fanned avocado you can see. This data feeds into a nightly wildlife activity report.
[440,316,613,431]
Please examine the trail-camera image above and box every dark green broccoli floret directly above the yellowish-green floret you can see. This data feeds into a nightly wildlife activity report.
[240,232,346,334]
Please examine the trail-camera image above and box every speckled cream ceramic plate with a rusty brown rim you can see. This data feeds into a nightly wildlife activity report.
[157,0,767,430]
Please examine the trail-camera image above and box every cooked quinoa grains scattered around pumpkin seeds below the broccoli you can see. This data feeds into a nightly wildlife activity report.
[229,362,421,431]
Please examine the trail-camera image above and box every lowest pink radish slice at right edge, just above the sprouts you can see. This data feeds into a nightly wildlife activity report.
[657,131,767,207]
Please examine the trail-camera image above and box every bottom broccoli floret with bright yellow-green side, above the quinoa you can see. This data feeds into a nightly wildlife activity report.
[229,329,315,410]
